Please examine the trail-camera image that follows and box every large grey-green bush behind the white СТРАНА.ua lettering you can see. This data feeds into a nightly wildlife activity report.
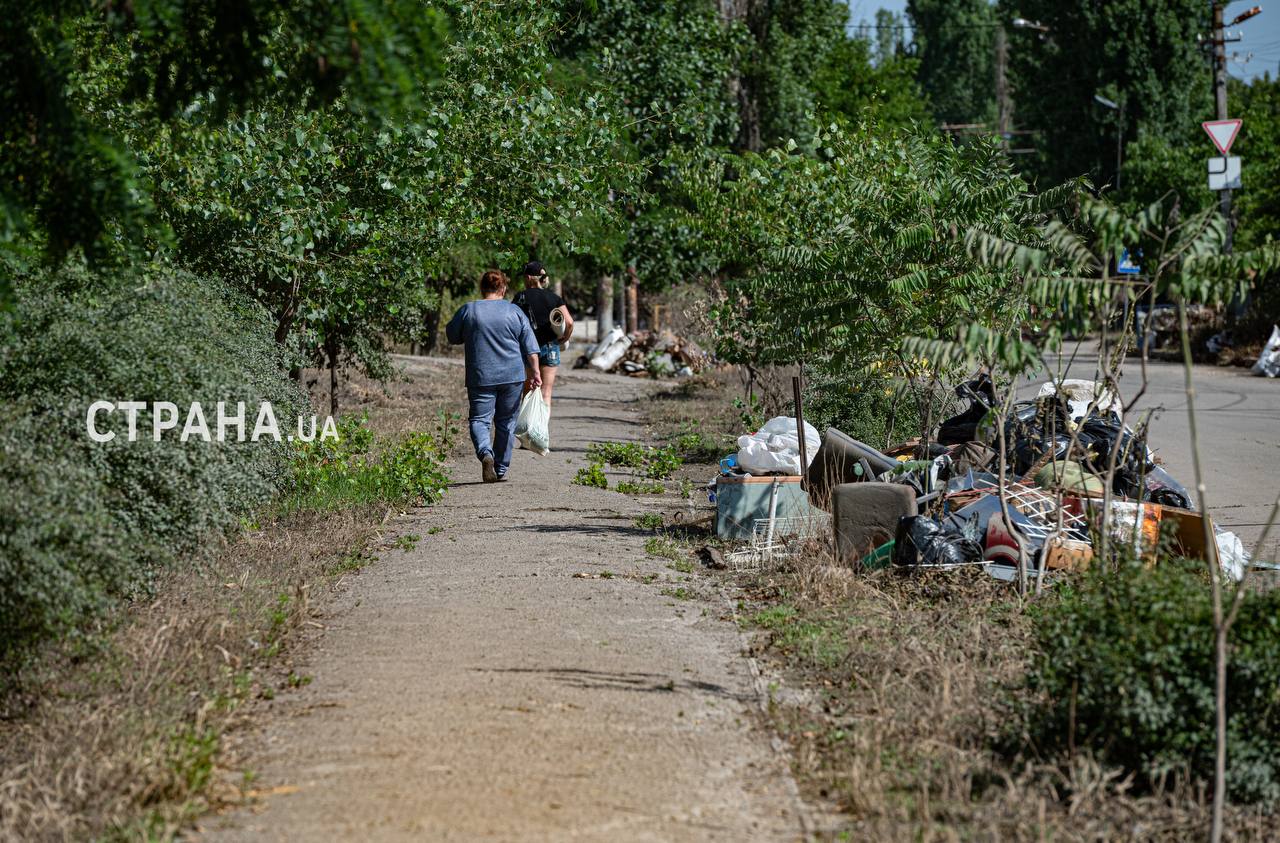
[0,266,306,665]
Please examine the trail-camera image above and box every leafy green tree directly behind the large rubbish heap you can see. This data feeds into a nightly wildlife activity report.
[687,124,1060,422]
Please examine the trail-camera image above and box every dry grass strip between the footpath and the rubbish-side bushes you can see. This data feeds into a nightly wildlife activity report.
[650,372,1280,840]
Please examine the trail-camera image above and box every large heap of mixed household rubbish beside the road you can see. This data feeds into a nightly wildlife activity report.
[717,377,1251,579]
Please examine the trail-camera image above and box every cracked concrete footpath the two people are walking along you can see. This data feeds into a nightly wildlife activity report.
[197,371,804,840]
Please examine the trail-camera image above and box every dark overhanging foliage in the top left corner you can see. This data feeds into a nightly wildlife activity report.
[0,0,447,258]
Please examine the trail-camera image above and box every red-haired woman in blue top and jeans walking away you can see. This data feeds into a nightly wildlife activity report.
[444,270,543,484]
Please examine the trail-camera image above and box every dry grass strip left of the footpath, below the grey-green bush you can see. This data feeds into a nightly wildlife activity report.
[0,355,461,840]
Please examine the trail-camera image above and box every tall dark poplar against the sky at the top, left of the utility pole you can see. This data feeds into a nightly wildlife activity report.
[906,0,996,123]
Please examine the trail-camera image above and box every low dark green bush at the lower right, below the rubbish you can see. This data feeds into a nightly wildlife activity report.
[1027,560,1280,802]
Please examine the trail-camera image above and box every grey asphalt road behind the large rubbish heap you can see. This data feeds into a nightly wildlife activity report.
[1020,354,1280,559]
